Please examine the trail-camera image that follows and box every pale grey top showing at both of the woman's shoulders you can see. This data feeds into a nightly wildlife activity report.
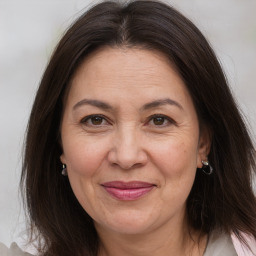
[0,232,240,256]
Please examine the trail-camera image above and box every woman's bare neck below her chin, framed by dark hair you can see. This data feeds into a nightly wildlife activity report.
[96,214,207,256]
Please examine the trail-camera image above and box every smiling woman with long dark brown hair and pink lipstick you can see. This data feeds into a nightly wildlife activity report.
[1,1,256,256]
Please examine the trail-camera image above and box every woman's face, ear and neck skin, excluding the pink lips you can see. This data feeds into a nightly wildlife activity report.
[60,47,210,256]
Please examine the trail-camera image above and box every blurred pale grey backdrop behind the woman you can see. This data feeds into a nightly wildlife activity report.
[0,0,256,252]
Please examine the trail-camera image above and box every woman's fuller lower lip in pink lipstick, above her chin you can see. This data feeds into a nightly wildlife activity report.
[104,186,154,201]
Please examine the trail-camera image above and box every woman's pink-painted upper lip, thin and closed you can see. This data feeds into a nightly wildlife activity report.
[101,181,156,189]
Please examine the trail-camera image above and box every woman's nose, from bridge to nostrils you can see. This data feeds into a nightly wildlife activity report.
[108,128,148,170]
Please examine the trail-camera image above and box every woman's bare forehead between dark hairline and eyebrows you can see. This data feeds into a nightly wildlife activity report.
[65,47,193,110]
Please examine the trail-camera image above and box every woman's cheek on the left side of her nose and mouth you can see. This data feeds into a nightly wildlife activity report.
[63,136,109,216]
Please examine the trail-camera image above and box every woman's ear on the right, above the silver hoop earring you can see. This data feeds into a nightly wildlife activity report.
[197,125,212,168]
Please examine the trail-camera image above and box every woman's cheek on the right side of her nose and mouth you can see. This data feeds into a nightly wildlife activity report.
[150,141,200,211]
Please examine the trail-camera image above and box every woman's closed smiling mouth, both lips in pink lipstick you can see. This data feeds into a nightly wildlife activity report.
[101,181,156,201]
